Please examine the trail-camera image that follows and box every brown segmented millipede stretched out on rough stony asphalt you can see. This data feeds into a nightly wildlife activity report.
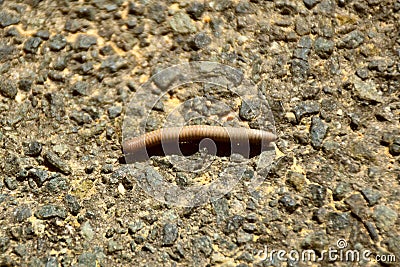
[122,125,277,163]
